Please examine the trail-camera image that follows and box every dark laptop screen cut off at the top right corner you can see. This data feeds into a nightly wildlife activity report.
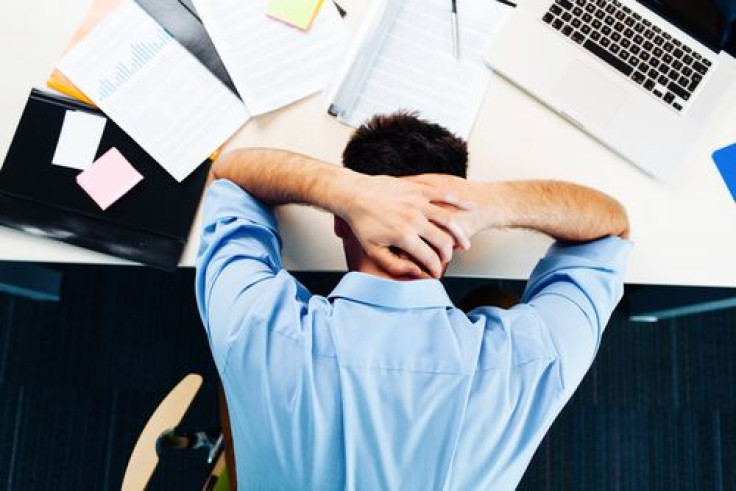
[638,0,736,56]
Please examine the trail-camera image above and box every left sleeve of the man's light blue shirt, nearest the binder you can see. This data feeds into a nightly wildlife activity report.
[196,180,306,367]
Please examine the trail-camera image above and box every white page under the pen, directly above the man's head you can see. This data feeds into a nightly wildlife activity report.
[334,0,511,138]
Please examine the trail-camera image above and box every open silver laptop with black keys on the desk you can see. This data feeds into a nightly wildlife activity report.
[483,0,736,179]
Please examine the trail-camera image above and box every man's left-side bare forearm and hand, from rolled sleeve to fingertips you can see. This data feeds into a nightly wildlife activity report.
[211,149,470,278]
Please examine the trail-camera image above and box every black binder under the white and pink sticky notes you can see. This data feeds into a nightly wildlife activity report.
[0,89,210,270]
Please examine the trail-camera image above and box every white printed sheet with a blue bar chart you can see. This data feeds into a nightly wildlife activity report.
[58,0,248,181]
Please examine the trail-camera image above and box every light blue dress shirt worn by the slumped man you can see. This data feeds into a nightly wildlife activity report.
[196,180,631,491]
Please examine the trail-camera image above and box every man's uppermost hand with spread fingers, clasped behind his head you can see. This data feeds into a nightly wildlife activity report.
[339,174,474,278]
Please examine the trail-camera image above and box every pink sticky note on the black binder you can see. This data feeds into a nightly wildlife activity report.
[77,148,143,210]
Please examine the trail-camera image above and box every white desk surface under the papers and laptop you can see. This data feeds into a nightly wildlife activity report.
[0,0,736,287]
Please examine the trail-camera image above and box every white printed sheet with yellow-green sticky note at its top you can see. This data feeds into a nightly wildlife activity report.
[194,0,346,115]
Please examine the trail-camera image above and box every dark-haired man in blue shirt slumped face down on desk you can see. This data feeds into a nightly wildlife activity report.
[196,114,630,490]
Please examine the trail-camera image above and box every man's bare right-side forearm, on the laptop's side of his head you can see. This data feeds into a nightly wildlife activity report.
[482,181,629,241]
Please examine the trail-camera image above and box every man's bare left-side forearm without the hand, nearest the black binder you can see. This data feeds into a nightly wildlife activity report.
[212,149,355,216]
